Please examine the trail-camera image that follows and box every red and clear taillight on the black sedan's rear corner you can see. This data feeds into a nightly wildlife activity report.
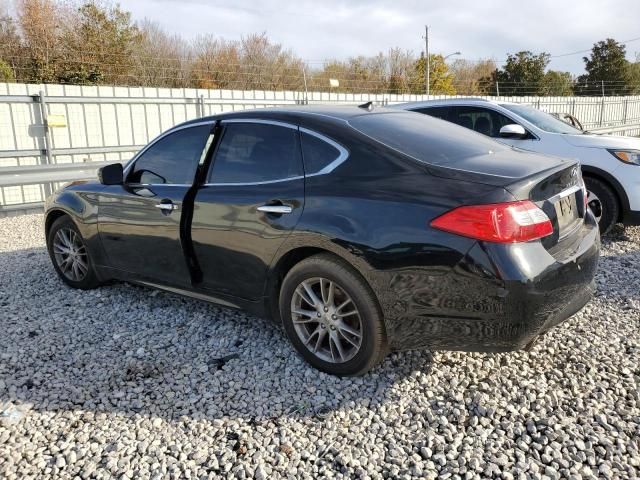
[431,200,553,243]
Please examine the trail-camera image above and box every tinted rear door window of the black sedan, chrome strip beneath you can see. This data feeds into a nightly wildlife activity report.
[209,122,302,183]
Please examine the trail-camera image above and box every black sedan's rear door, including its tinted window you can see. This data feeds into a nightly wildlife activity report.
[191,119,304,300]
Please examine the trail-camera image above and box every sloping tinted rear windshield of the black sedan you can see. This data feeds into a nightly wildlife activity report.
[349,112,508,165]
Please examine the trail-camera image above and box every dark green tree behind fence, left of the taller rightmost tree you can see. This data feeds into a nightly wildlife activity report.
[484,50,550,96]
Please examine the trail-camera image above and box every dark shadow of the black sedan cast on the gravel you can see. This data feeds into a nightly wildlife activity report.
[0,248,433,422]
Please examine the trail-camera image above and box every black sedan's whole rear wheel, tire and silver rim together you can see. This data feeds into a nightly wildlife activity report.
[279,254,387,376]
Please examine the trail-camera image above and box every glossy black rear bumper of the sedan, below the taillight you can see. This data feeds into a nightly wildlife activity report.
[386,217,600,352]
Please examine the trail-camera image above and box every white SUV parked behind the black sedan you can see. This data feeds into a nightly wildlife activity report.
[395,98,640,233]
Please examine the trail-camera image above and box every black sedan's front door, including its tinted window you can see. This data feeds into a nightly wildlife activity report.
[98,123,213,287]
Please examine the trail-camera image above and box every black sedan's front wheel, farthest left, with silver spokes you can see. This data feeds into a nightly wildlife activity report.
[47,215,100,290]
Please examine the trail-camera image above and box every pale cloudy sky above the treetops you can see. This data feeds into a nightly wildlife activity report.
[120,0,640,74]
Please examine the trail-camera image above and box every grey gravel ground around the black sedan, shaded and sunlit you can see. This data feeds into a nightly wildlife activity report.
[0,215,640,479]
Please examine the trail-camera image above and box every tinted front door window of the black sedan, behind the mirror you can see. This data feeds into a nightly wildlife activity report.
[127,125,211,185]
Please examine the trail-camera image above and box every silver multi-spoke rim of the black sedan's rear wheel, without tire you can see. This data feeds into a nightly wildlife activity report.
[291,277,363,363]
